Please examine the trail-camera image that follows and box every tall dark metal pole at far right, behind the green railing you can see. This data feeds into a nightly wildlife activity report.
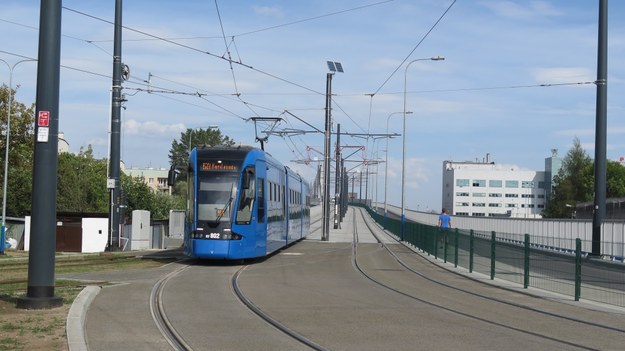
[592,0,608,256]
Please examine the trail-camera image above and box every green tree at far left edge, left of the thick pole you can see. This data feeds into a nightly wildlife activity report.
[0,84,35,217]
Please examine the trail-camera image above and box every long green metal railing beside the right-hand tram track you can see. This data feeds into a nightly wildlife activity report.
[354,204,625,307]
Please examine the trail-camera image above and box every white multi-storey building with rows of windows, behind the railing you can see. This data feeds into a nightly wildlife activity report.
[442,161,550,218]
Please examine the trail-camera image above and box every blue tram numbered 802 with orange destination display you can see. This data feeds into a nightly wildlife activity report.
[177,146,310,259]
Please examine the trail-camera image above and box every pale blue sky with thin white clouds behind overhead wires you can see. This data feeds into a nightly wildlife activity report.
[0,0,625,211]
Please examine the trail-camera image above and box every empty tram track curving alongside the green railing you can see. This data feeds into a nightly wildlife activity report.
[352,209,625,350]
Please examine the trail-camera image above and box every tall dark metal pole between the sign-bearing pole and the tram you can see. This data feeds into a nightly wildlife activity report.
[108,0,122,251]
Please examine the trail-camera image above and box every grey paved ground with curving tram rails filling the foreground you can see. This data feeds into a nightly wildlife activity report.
[62,209,625,350]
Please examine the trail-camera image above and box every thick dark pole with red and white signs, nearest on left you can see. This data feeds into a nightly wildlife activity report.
[17,0,63,309]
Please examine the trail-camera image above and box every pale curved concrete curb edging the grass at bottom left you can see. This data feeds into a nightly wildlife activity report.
[65,285,101,351]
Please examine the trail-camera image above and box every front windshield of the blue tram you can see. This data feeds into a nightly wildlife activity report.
[197,172,238,221]
